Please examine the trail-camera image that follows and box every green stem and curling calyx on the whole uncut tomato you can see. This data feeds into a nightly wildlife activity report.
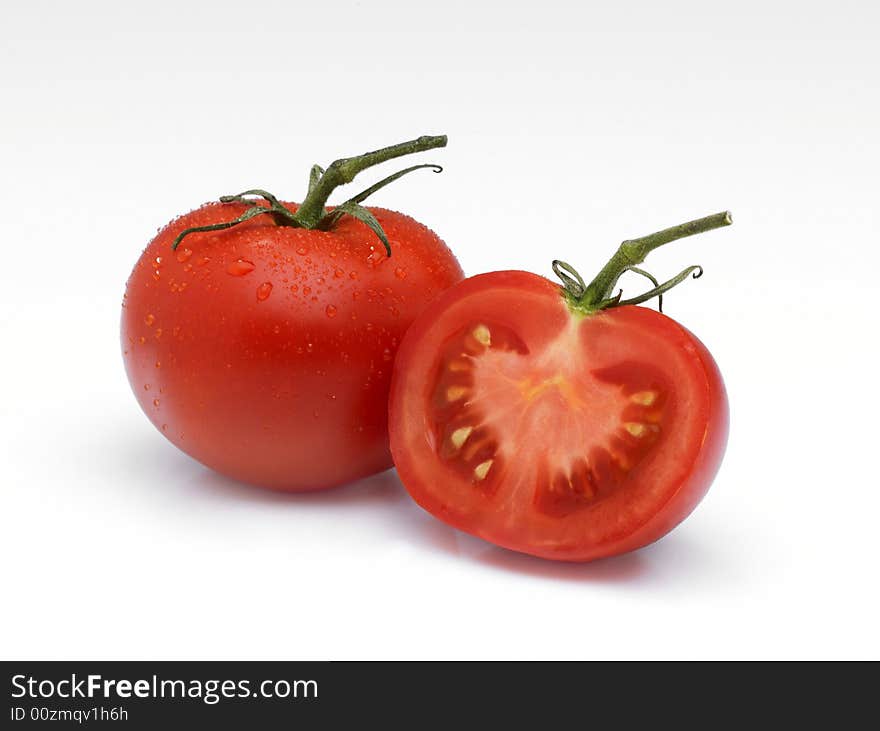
[171,135,446,256]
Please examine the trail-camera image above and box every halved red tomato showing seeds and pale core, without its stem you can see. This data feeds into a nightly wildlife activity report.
[390,272,727,560]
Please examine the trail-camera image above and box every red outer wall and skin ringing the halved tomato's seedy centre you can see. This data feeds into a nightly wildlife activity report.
[389,271,729,562]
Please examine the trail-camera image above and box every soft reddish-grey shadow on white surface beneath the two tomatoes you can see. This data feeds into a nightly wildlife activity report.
[111,428,724,588]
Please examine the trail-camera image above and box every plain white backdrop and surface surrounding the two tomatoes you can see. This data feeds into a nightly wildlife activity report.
[0,0,880,659]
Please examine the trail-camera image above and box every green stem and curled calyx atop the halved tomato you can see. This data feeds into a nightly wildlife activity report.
[553,211,733,315]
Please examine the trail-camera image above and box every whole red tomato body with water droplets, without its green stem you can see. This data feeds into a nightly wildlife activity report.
[121,203,463,491]
